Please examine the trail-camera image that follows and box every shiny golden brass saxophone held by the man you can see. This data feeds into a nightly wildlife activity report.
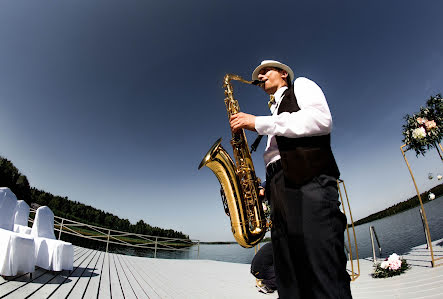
[198,74,269,248]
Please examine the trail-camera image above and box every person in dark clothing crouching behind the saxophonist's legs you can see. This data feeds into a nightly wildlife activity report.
[251,242,277,294]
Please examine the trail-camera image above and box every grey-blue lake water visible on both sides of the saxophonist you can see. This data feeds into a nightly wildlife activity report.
[120,197,443,264]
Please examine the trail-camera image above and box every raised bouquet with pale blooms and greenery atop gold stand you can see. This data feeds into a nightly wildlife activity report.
[403,94,443,156]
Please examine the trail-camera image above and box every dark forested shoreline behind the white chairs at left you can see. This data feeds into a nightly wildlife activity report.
[0,156,189,239]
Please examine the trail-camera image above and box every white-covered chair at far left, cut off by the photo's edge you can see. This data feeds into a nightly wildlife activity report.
[0,187,35,276]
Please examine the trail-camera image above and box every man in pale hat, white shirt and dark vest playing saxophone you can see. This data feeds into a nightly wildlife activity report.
[230,60,352,299]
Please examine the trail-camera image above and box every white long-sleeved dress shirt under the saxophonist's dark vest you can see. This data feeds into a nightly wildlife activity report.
[255,77,332,166]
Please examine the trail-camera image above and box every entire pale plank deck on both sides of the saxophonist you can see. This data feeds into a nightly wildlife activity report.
[0,240,443,299]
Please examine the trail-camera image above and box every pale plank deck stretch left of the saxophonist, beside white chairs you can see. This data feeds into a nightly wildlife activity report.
[0,247,262,298]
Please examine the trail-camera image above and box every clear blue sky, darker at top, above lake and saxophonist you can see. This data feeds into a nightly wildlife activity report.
[0,0,443,241]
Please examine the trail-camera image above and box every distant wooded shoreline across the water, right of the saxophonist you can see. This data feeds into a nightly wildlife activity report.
[354,184,443,226]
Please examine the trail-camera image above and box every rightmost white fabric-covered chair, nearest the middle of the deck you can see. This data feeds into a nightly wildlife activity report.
[31,206,74,271]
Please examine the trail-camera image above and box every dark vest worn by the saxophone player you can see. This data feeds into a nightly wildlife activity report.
[275,87,340,186]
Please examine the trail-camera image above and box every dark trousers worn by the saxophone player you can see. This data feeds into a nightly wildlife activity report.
[266,171,352,299]
